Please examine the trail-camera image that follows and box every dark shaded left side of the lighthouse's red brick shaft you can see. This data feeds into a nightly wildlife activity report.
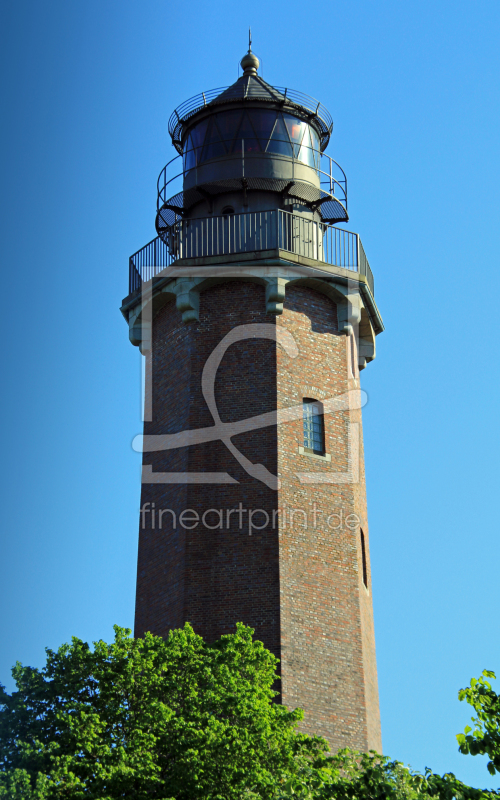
[136,282,280,657]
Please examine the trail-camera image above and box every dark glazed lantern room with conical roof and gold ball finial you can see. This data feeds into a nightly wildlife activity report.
[156,50,348,240]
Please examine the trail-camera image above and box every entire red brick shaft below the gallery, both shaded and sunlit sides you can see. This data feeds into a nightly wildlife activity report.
[136,281,381,749]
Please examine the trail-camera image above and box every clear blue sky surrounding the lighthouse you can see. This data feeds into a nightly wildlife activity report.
[0,0,500,786]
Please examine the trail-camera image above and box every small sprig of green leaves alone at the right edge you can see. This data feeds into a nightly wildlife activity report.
[457,669,500,775]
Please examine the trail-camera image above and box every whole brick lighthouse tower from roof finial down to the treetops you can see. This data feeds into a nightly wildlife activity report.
[122,48,383,751]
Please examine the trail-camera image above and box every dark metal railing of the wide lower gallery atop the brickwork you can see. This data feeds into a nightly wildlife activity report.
[129,209,374,293]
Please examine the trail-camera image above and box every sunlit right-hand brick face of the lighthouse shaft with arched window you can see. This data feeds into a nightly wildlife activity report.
[277,286,381,749]
